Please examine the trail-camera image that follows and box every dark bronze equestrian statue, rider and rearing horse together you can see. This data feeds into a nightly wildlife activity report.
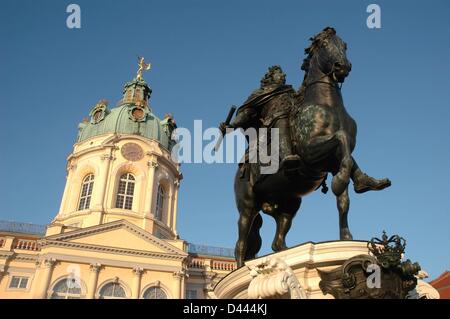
[220,27,391,266]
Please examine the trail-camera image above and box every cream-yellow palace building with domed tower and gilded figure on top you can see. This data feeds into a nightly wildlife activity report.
[0,59,236,299]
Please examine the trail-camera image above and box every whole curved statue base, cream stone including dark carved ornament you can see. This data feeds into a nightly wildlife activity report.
[209,241,439,299]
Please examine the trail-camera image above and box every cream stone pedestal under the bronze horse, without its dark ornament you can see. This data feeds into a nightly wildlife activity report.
[209,241,435,299]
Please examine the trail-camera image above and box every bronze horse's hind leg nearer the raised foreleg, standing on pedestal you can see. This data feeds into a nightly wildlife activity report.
[272,198,302,252]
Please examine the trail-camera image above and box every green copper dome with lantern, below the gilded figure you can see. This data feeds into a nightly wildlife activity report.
[77,79,176,150]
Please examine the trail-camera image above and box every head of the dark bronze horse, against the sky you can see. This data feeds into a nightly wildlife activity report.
[302,27,352,82]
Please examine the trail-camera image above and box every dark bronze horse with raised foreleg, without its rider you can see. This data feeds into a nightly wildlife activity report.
[230,28,391,266]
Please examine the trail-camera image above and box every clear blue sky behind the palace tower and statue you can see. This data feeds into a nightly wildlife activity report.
[0,0,450,277]
